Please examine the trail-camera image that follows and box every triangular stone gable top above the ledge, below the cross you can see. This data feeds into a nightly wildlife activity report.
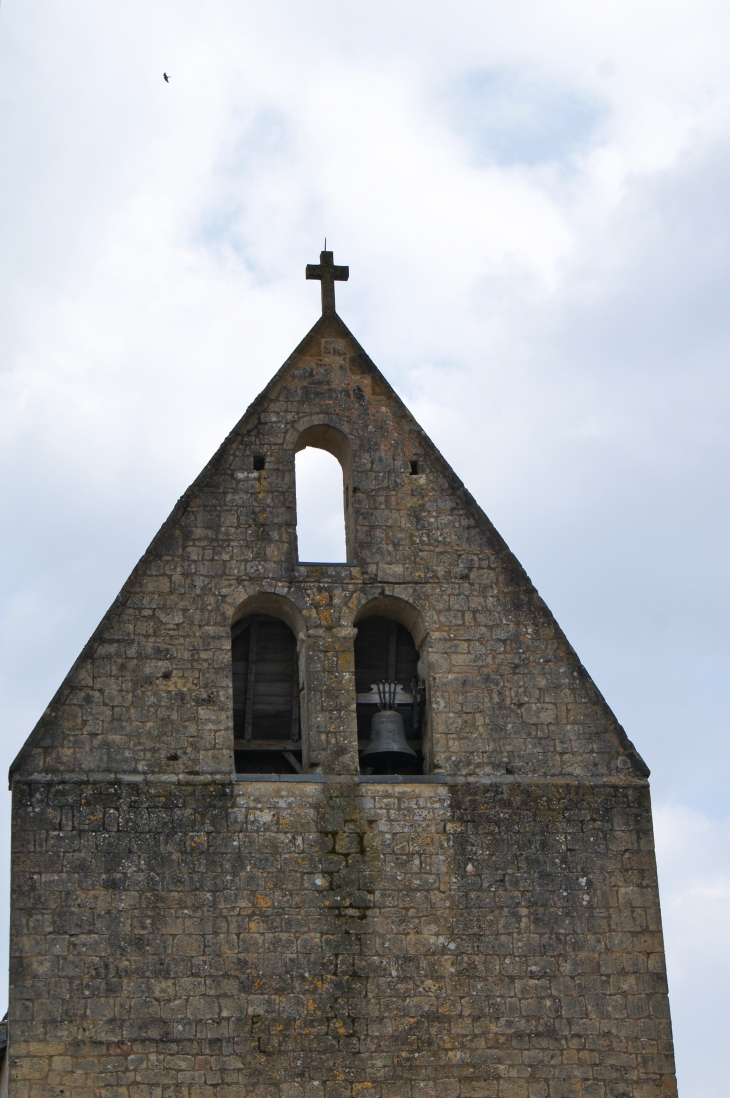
[11,274,648,780]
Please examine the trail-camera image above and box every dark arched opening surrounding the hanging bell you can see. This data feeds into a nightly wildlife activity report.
[355,615,425,774]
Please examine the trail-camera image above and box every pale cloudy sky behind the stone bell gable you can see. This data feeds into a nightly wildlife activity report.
[0,0,730,1098]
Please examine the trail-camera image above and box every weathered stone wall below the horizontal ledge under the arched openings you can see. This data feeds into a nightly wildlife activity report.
[10,775,675,1098]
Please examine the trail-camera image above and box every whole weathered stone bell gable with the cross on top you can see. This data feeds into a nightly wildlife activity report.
[9,251,676,1098]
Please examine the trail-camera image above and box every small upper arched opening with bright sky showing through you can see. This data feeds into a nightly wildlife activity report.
[296,446,347,564]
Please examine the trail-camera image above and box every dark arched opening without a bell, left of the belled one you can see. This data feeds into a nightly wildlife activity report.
[231,614,302,774]
